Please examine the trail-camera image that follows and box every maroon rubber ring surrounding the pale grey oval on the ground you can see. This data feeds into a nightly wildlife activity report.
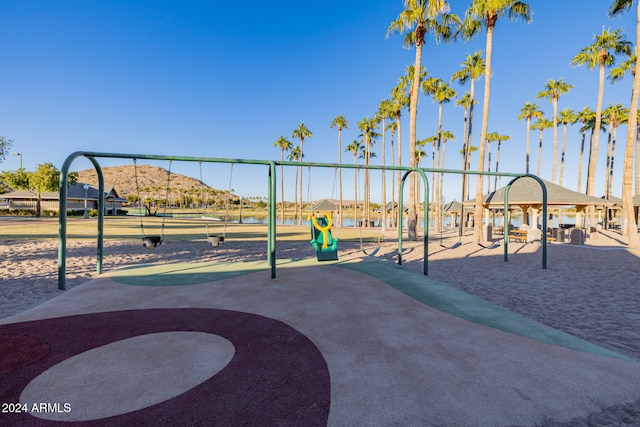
[0,308,330,426]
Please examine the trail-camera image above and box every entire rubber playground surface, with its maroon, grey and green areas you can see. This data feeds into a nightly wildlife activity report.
[0,258,640,426]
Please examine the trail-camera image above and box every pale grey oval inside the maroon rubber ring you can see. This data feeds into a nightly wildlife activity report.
[20,331,235,421]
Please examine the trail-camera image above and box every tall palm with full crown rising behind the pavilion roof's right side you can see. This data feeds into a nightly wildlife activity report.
[571,28,631,227]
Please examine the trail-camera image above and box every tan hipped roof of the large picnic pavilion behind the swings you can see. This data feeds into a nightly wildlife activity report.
[465,177,614,208]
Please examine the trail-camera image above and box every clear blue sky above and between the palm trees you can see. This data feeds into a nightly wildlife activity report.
[0,0,635,200]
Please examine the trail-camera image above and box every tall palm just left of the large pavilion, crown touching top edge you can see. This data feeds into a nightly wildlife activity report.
[462,0,531,242]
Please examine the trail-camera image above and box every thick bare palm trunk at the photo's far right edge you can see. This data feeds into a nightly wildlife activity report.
[609,0,640,245]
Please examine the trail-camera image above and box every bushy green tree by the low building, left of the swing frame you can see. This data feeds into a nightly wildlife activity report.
[2,163,78,218]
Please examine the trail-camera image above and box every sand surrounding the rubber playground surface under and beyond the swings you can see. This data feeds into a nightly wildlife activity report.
[0,230,640,425]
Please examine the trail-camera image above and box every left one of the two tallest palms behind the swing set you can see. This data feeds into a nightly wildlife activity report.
[387,0,460,240]
